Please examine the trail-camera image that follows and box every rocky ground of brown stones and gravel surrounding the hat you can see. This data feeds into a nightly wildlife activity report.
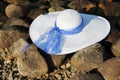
[0,0,120,80]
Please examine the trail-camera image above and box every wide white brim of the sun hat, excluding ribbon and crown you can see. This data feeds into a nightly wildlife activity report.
[29,11,110,55]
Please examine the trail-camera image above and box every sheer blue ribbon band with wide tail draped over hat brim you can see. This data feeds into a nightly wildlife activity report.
[34,20,84,54]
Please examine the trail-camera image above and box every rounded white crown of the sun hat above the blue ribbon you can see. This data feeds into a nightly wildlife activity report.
[56,9,82,30]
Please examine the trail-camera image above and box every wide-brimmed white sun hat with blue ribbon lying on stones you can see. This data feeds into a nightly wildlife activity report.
[29,9,110,55]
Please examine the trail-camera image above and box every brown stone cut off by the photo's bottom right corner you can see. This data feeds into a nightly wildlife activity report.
[98,57,120,80]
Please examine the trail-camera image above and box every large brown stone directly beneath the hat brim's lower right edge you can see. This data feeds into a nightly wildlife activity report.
[70,44,105,72]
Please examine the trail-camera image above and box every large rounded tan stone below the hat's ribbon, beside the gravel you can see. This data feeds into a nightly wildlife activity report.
[17,45,48,77]
